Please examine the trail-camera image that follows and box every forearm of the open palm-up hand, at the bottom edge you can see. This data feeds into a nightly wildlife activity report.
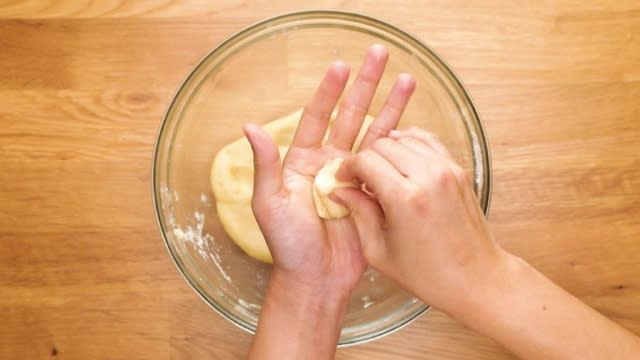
[248,273,349,360]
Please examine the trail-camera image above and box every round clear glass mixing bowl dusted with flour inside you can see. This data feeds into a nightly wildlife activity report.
[153,11,491,345]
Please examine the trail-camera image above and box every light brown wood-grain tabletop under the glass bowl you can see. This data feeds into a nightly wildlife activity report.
[0,0,640,360]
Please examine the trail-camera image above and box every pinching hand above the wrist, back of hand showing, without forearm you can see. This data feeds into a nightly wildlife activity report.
[334,128,505,311]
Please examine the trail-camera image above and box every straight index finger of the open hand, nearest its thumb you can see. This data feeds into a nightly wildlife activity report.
[292,61,349,148]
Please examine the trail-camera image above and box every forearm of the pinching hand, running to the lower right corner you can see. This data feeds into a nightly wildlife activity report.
[450,255,640,359]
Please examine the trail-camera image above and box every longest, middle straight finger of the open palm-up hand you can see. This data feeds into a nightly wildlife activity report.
[329,45,389,151]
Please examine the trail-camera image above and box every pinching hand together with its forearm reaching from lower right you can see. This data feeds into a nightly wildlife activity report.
[335,133,640,359]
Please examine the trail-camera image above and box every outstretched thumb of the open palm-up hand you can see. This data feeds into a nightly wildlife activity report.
[242,124,282,200]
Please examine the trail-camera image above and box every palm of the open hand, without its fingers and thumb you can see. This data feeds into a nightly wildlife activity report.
[272,145,366,287]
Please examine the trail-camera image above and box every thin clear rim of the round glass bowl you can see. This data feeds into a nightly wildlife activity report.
[151,9,493,347]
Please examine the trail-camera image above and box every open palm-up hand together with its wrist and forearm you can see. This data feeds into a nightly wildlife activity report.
[244,45,415,360]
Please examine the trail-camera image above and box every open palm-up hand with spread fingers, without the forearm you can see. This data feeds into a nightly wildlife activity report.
[245,46,415,289]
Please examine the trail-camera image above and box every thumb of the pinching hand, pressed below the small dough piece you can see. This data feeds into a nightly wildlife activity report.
[332,188,386,264]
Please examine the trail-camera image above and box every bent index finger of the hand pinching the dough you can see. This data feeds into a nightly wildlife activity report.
[336,150,407,208]
